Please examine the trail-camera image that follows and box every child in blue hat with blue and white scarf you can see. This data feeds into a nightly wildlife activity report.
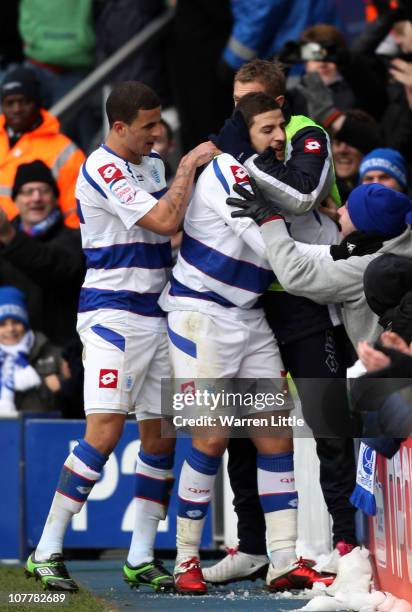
[0,287,60,415]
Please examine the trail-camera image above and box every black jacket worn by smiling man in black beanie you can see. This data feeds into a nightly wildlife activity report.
[0,217,84,346]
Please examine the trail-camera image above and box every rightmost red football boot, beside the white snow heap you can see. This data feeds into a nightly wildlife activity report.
[266,557,335,591]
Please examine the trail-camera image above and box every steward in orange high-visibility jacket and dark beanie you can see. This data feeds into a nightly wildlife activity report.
[0,68,85,227]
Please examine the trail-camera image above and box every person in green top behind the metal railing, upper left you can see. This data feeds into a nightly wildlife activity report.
[19,0,101,151]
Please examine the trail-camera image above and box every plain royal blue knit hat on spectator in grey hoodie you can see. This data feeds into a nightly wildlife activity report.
[348,183,412,236]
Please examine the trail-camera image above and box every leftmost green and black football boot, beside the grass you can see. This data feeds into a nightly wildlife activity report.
[24,553,79,593]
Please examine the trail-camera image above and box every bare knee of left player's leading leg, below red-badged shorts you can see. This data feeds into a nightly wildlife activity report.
[84,413,126,456]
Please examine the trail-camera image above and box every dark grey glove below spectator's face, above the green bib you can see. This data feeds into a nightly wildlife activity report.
[296,72,341,127]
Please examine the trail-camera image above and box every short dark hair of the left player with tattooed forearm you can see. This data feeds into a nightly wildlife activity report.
[106,81,160,127]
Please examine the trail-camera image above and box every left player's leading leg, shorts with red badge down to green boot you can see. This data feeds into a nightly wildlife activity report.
[26,330,128,591]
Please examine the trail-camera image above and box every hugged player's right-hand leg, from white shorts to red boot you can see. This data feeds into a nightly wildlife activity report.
[242,319,332,590]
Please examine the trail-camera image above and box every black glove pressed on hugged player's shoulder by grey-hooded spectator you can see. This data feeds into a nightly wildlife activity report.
[226,177,283,225]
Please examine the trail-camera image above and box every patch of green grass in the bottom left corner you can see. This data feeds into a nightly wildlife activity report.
[0,566,115,612]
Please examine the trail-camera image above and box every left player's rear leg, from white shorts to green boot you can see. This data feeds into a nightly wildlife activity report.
[123,332,175,591]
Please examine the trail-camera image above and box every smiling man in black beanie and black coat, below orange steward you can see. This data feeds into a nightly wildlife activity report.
[0,160,84,346]
